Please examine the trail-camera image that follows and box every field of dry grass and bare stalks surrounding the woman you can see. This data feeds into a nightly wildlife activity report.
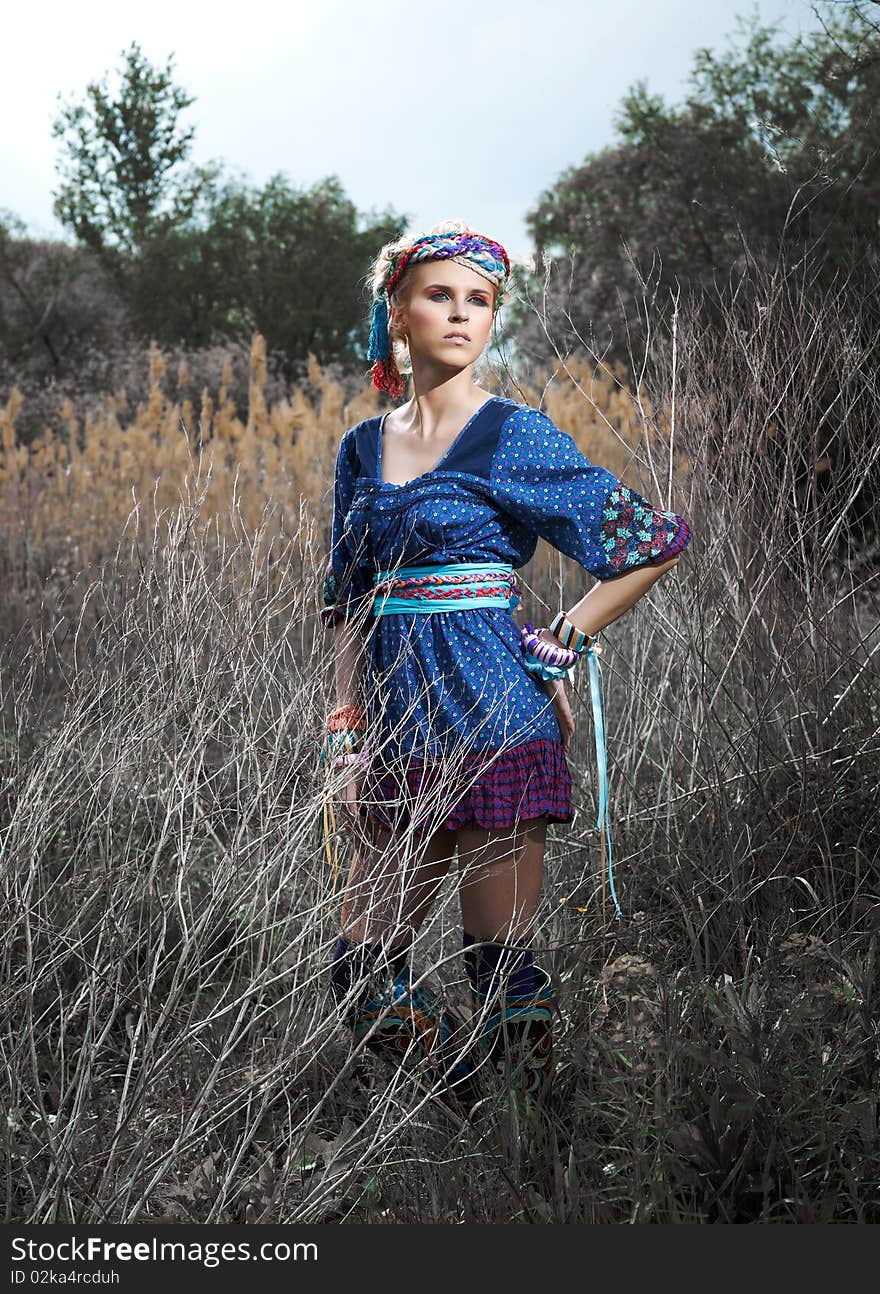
[0,262,880,1224]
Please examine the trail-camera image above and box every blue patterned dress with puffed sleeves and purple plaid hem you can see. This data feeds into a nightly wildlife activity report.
[321,396,690,832]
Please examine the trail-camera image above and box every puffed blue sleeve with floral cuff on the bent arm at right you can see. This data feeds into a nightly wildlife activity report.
[489,406,691,580]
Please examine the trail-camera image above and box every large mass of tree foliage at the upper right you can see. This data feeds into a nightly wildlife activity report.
[515,4,880,372]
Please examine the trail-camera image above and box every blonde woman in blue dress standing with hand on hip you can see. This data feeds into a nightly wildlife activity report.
[322,221,690,1096]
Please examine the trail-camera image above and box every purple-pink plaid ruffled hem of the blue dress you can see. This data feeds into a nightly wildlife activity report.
[361,738,575,832]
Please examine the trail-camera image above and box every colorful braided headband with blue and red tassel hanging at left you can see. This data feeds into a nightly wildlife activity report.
[366,230,510,397]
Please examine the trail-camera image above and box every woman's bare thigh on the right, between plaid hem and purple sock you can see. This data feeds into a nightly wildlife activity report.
[457,818,547,942]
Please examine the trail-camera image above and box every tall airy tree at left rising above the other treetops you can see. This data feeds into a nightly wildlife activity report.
[52,41,217,277]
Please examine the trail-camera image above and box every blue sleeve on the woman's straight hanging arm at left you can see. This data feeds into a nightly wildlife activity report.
[321,428,373,628]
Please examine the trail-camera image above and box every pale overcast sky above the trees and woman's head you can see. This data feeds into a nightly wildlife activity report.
[0,0,833,259]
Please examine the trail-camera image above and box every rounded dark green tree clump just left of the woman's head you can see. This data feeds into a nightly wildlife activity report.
[132,173,404,375]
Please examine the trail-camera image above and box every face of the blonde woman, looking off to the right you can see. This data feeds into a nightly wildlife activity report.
[400,260,496,369]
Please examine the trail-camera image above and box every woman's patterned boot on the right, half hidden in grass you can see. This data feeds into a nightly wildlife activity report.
[471,967,559,1108]
